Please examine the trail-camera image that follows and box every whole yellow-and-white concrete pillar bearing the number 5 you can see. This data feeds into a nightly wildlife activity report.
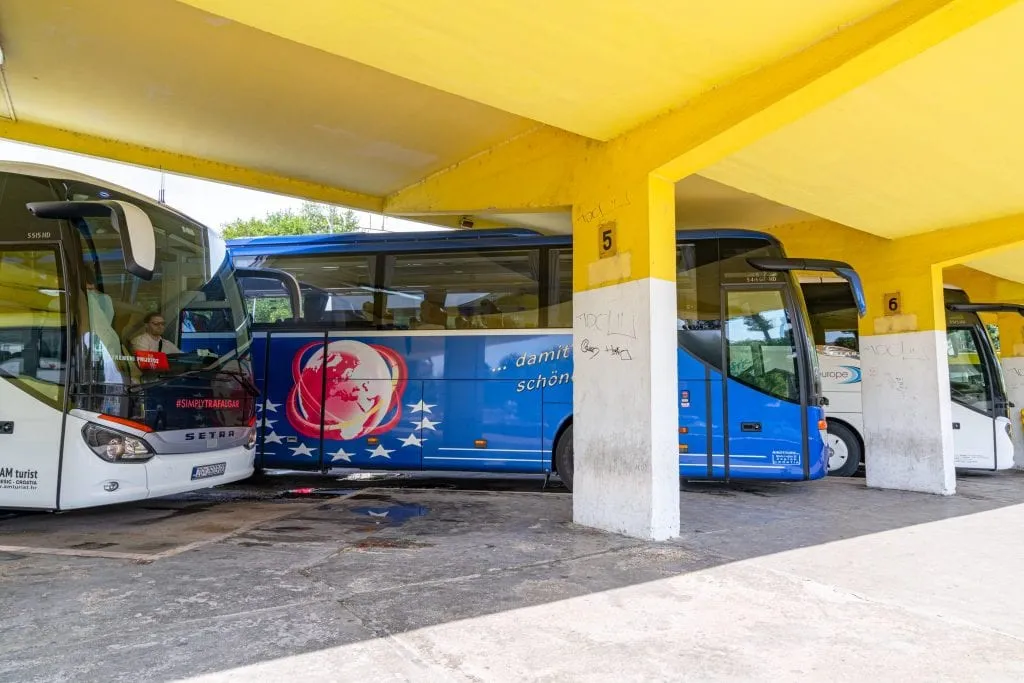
[572,176,679,540]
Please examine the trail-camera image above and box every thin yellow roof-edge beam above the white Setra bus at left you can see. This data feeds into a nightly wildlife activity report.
[0,119,384,212]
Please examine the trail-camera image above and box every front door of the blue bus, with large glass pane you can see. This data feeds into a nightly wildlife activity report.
[713,284,809,479]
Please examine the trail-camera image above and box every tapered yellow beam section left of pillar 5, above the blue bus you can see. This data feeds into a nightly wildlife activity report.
[384,126,595,216]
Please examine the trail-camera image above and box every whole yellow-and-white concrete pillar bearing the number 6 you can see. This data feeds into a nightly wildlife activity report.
[860,259,956,495]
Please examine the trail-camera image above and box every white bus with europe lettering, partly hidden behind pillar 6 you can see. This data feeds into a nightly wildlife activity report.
[801,278,1022,476]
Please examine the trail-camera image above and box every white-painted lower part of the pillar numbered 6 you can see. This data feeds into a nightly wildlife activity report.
[860,330,956,496]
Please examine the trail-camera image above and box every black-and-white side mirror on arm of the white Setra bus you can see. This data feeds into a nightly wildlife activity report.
[26,200,157,280]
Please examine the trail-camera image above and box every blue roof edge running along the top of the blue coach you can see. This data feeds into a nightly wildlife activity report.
[227,228,778,254]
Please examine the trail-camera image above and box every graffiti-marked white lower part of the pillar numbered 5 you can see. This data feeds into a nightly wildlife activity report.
[572,279,679,541]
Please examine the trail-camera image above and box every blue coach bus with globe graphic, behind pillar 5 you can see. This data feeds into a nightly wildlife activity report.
[228,229,863,488]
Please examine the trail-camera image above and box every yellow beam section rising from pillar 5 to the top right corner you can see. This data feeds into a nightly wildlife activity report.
[630,0,1017,180]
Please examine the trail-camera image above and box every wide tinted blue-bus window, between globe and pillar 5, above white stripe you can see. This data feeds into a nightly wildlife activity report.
[384,250,541,330]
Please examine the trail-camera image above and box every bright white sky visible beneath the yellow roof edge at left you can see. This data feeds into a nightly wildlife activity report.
[0,139,438,232]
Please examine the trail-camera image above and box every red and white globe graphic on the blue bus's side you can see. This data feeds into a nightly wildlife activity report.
[288,339,407,440]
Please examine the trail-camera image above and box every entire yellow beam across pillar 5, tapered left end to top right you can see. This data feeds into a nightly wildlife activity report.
[385,0,1017,215]
